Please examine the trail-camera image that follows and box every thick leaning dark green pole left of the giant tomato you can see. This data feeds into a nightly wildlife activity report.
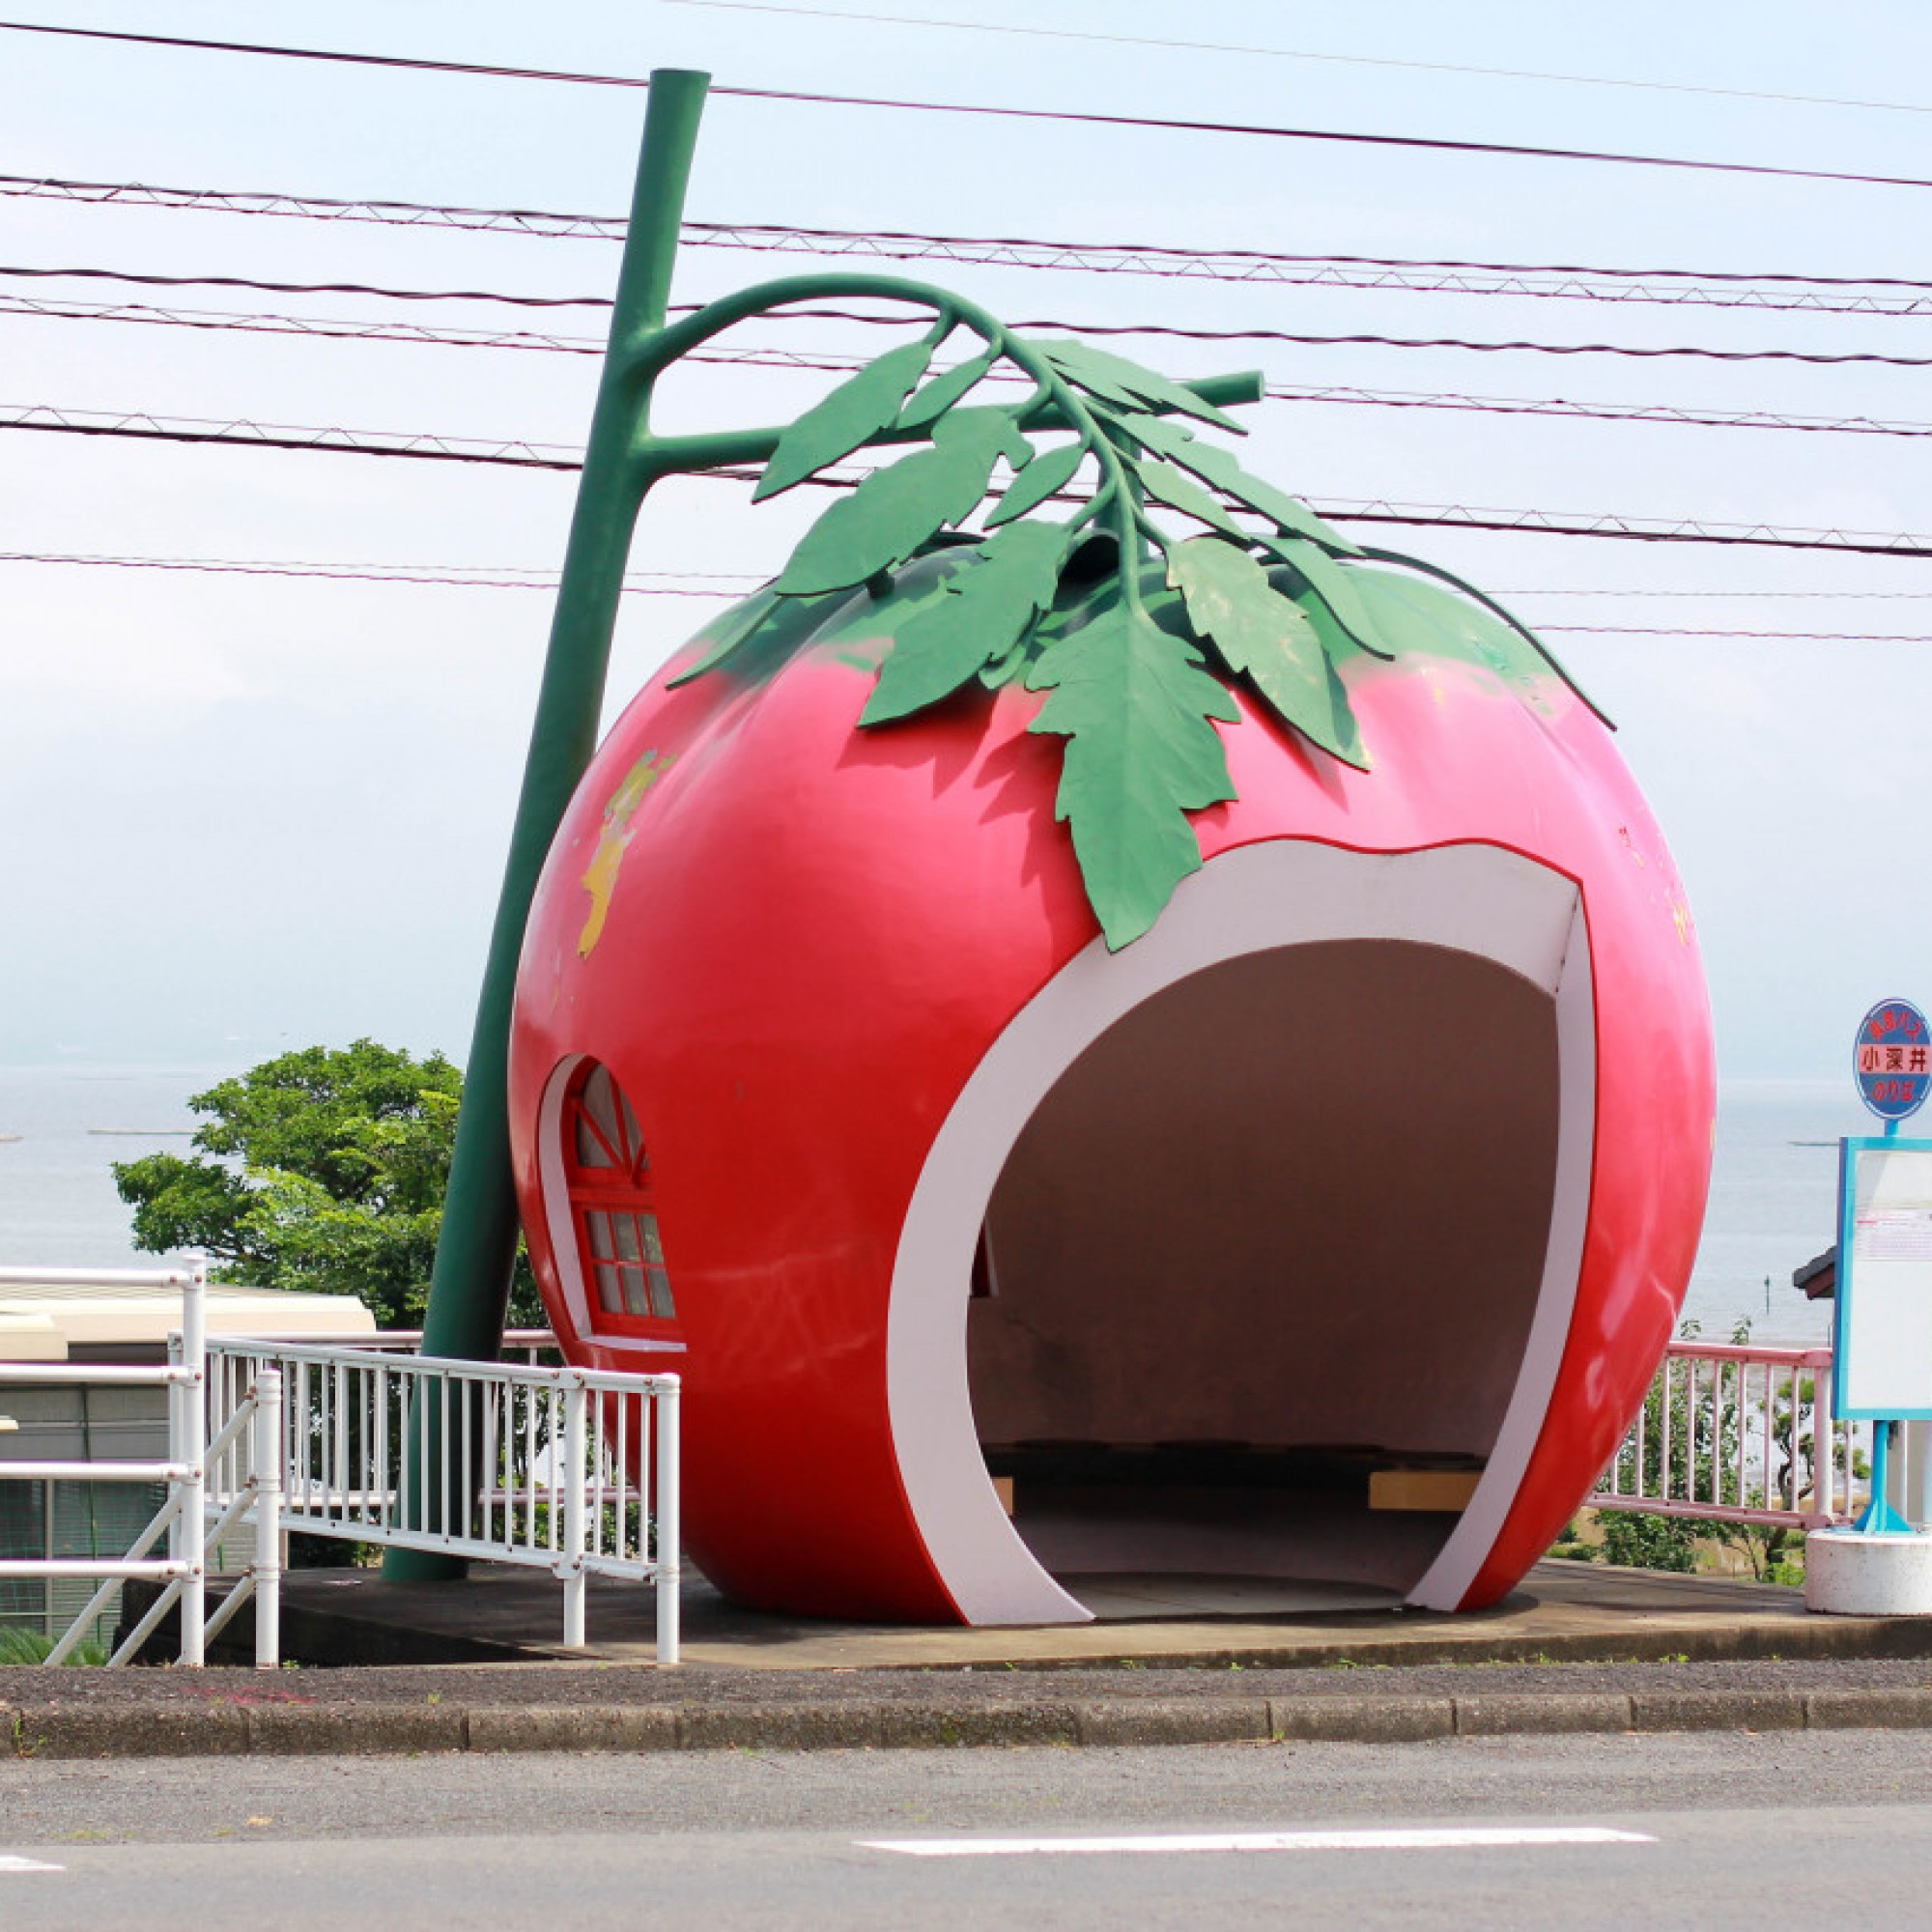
[383,68,711,1582]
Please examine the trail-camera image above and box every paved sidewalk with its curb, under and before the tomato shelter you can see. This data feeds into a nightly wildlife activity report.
[11,1563,1932,1758]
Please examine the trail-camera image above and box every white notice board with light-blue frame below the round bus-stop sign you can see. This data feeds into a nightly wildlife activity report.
[1832,1138,1932,1422]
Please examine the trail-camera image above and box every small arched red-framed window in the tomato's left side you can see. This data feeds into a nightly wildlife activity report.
[562,1061,678,1321]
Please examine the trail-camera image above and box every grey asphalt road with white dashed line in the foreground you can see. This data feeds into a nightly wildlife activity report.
[0,1731,1932,1932]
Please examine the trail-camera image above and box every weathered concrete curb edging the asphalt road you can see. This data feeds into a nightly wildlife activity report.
[11,1687,1932,1758]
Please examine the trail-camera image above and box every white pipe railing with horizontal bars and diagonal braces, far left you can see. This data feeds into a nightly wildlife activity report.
[0,1262,282,1667]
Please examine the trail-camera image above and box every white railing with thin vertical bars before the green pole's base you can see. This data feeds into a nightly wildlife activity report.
[211,1339,682,1663]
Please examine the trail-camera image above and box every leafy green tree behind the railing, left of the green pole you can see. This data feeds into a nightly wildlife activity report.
[114,1039,547,1327]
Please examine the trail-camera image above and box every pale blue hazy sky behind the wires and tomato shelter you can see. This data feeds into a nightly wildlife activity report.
[0,0,1932,1074]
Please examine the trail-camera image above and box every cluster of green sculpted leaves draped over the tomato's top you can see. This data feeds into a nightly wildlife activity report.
[678,309,1592,949]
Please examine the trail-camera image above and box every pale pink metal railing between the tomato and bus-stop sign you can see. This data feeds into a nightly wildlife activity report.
[1586,1339,1861,1530]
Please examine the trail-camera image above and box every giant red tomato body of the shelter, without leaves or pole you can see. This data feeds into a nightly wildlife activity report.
[510,537,1714,1623]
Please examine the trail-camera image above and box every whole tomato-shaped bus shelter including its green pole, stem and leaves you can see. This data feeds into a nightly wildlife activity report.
[404,71,1712,1623]
